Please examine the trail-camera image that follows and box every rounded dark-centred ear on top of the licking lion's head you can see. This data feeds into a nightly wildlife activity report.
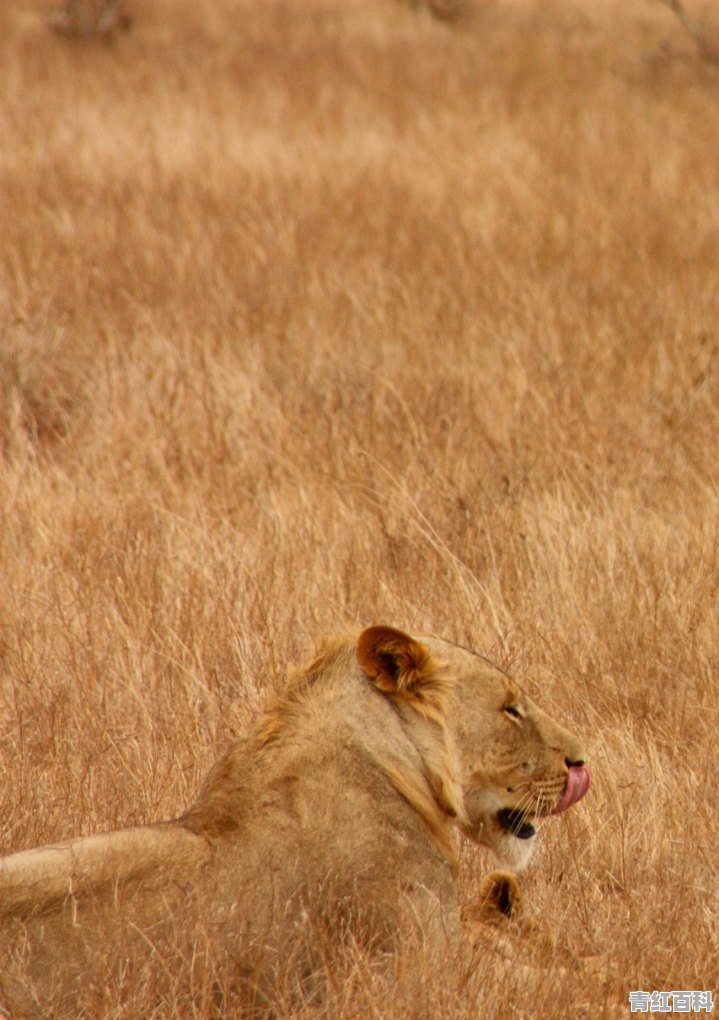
[357,626,436,694]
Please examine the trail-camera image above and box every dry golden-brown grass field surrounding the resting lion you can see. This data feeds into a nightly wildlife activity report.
[0,0,719,1020]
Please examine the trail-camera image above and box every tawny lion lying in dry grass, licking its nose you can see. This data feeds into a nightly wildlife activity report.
[0,625,589,1018]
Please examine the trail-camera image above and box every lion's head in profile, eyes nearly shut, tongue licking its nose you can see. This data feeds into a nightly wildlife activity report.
[357,627,589,871]
